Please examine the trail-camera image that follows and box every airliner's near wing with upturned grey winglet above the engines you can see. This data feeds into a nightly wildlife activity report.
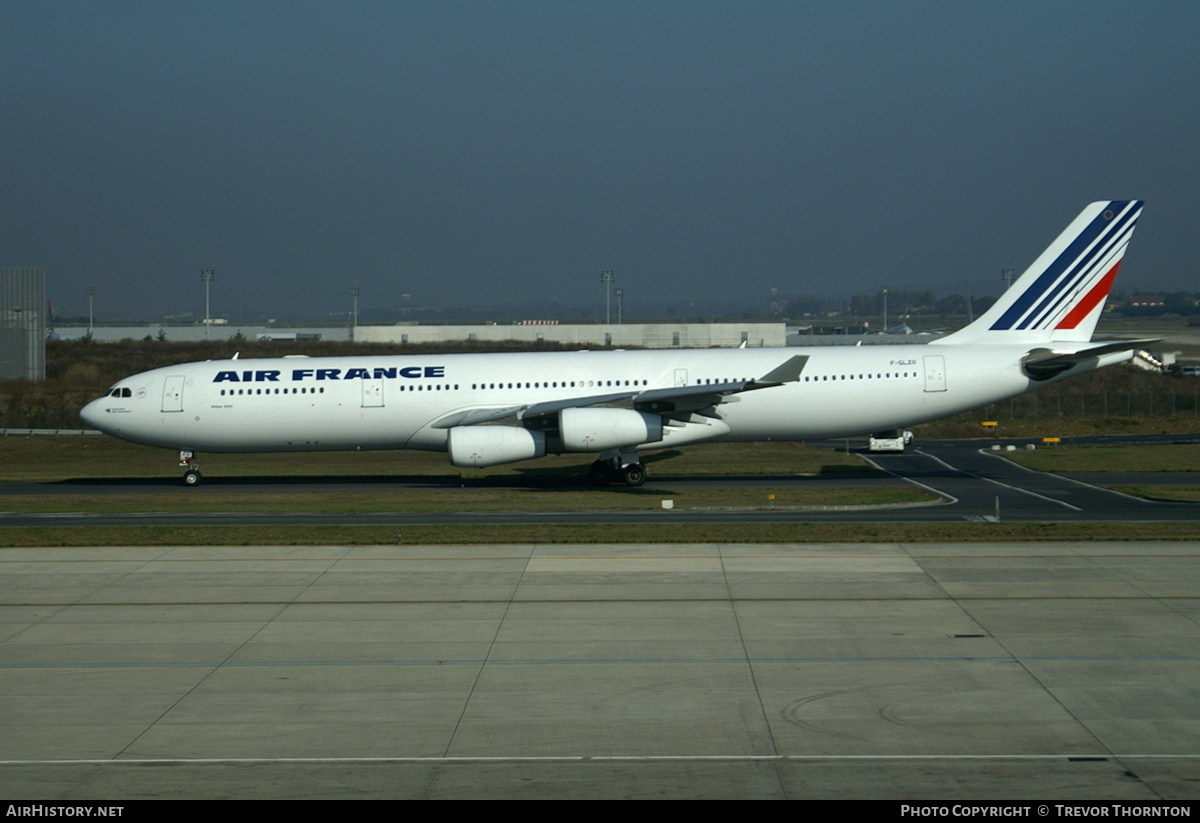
[432,355,809,428]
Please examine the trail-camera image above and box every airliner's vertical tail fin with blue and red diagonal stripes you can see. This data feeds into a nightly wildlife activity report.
[937,200,1142,343]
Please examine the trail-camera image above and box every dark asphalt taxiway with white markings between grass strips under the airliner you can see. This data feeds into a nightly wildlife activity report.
[0,434,1200,525]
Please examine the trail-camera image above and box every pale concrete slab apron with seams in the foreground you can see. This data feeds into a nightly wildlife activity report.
[0,542,1200,801]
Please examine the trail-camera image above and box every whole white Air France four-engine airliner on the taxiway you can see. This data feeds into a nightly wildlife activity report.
[82,200,1152,486]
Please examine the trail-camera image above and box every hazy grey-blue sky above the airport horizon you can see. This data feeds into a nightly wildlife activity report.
[0,0,1200,317]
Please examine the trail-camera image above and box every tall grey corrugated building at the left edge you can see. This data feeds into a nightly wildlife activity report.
[0,268,46,380]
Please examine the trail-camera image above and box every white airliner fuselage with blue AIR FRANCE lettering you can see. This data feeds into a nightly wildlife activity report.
[83,342,1113,452]
